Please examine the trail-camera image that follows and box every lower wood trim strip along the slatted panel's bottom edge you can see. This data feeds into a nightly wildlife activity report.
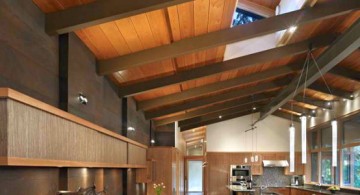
[0,157,146,168]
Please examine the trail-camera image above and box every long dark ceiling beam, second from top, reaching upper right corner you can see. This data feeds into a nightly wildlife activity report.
[98,0,360,75]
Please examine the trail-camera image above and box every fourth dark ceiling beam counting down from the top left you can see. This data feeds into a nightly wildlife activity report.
[137,65,297,110]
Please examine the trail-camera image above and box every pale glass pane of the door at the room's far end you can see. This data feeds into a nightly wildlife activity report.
[188,161,203,192]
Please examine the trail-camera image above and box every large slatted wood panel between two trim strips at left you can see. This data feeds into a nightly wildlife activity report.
[7,100,127,164]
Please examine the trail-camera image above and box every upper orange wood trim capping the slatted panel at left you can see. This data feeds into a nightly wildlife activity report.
[0,88,148,149]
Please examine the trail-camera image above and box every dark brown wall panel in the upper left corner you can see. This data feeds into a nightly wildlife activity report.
[0,0,59,106]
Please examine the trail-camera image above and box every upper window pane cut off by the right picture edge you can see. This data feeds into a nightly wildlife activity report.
[343,115,360,144]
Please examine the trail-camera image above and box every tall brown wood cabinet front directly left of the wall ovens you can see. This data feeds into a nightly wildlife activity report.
[206,153,230,195]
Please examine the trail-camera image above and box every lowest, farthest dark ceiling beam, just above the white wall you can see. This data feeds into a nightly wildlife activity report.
[179,102,264,128]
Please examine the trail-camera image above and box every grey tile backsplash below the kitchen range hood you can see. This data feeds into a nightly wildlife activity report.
[253,167,291,187]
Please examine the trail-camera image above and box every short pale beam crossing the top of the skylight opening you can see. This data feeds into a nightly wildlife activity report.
[237,0,275,18]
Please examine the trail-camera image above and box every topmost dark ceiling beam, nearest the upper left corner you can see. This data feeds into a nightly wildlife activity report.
[45,0,193,35]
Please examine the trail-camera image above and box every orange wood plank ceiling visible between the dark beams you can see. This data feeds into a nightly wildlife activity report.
[33,0,360,129]
